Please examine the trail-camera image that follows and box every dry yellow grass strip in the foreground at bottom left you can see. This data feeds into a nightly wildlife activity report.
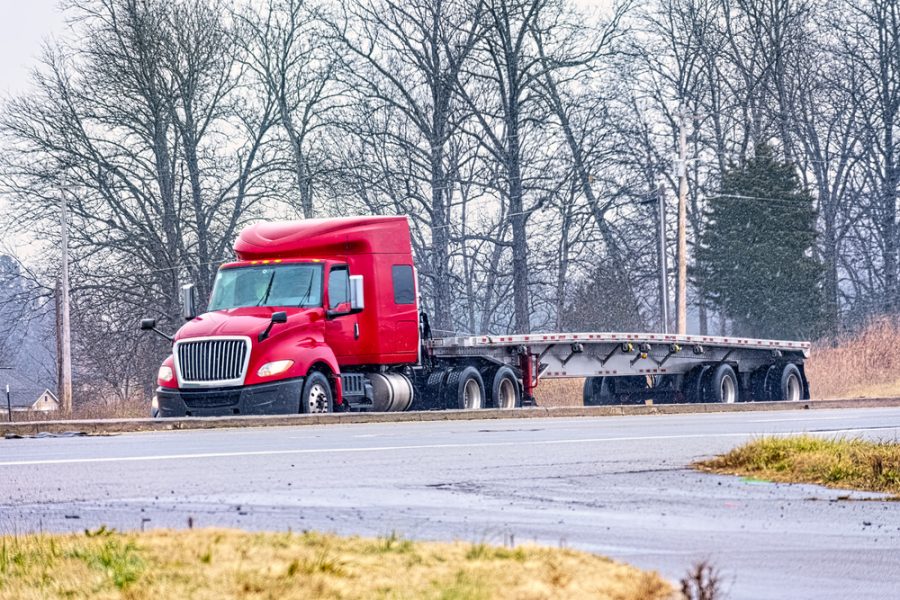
[0,529,672,600]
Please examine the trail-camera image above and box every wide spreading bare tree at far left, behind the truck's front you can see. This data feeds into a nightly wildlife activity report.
[0,0,272,406]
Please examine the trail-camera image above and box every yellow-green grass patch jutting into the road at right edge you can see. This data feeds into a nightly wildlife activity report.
[694,435,900,496]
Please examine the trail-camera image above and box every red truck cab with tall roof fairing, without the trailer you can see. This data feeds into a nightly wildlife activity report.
[150,217,420,417]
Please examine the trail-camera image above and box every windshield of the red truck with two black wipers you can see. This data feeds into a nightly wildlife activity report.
[209,263,322,311]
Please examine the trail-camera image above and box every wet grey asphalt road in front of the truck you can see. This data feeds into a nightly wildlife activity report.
[0,408,900,599]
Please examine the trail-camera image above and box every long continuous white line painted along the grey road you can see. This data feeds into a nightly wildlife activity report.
[0,427,888,467]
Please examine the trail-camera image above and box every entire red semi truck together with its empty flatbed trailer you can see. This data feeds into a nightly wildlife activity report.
[141,217,809,417]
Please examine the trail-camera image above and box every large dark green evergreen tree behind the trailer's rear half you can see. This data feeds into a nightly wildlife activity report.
[697,145,824,339]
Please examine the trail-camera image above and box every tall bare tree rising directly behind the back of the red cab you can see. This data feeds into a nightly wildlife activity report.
[335,0,482,330]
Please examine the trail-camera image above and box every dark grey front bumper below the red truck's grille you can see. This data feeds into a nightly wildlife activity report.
[156,377,303,417]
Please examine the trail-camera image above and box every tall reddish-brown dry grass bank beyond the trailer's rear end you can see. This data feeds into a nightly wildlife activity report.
[806,319,900,399]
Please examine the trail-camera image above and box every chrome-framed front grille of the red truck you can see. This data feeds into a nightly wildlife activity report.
[178,338,250,385]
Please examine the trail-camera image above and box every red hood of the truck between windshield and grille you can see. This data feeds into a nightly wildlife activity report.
[175,306,322,340]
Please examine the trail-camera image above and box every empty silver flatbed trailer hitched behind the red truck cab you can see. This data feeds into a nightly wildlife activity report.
[413,333,810,408]
